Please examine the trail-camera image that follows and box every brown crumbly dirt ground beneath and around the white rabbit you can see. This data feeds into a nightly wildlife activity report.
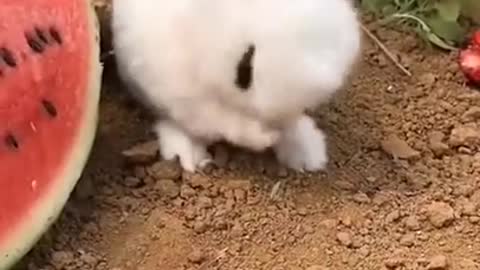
[13,16,480,270]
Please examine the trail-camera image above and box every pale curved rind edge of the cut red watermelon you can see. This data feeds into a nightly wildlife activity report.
[0,0,103,270]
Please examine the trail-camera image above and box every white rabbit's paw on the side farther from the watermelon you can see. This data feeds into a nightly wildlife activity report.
[274,116,328,171]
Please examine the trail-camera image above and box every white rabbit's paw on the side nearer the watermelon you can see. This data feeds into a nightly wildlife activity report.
[155,121,212,172]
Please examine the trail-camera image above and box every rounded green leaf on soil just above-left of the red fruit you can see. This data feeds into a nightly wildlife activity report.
[426,16,465,43]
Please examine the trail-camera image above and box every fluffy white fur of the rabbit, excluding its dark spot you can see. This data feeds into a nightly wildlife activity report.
[113,0,360,171]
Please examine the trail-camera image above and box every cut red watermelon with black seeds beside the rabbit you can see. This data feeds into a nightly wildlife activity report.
[0,0,102,269]
